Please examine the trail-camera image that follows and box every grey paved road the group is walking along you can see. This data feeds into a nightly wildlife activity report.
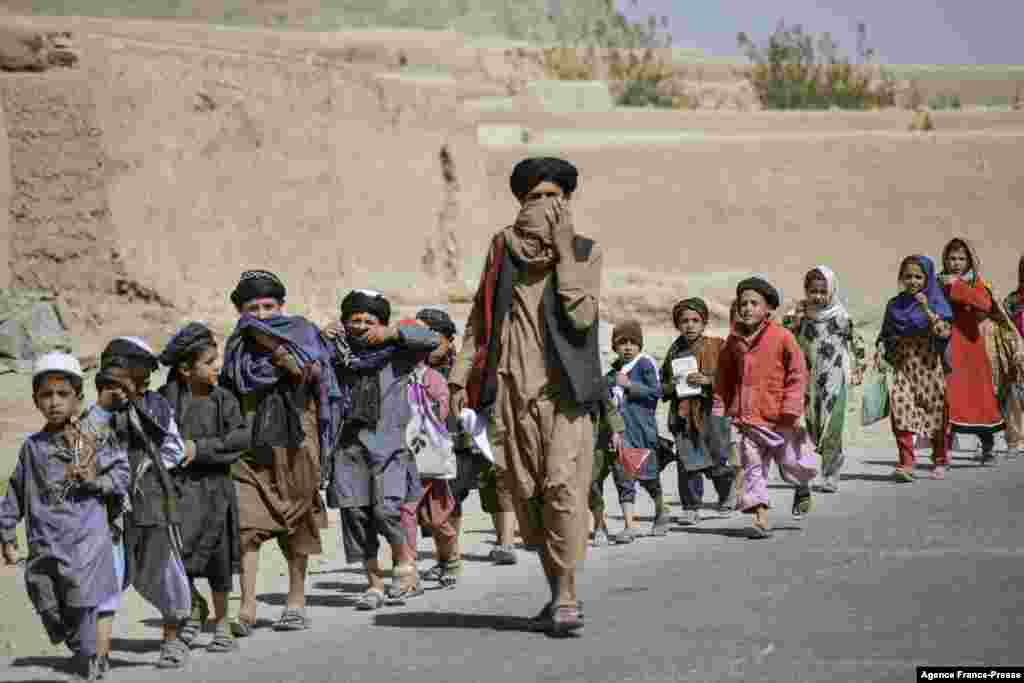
[0,450,1024,683]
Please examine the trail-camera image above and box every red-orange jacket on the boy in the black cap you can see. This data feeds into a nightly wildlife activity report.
[714,321,807,428]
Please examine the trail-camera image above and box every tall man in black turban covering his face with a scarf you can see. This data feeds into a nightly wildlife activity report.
[450,158,606,635]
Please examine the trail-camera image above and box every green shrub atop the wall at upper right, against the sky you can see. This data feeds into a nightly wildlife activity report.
[736,22,896,110]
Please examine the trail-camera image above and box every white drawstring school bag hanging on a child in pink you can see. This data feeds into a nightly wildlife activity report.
[406,366,459,479]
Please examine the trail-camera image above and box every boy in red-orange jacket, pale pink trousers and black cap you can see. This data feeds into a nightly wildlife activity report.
[713,278,817,539]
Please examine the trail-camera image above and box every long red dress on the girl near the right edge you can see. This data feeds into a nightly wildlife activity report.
[946,280,1004,437]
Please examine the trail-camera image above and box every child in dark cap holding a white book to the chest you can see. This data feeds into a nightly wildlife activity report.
[662,298,735,524]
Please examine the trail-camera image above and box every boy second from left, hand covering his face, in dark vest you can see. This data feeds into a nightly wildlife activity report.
[95,337,195,669]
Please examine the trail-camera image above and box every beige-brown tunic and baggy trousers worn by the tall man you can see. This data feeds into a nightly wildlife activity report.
[450,228,603,571]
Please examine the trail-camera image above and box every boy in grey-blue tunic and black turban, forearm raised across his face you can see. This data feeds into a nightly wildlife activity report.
[330,290,441,610]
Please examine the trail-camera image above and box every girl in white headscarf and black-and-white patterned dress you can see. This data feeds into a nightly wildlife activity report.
[782,265,864,494]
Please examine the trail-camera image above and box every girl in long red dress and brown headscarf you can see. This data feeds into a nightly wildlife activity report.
[941,238,1005,465]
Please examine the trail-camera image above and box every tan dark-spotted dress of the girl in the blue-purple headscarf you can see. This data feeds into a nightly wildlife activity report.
[887,335,946,437]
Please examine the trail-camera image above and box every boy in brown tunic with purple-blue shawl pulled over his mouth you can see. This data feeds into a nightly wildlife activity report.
[220,270,341,637]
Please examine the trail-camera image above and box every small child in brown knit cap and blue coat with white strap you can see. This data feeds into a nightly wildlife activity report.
[607,321,669,544]
